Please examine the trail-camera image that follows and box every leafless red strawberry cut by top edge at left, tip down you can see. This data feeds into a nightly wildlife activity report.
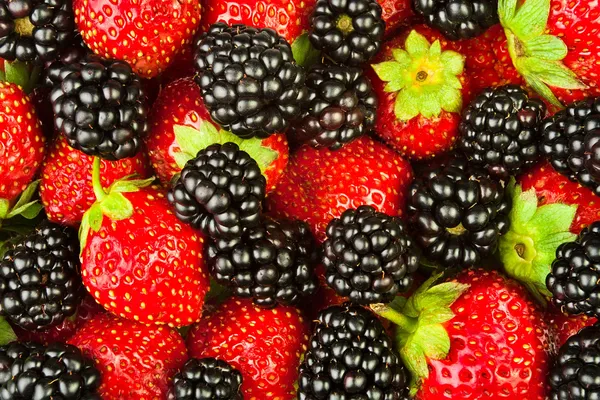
[73,0,200,78]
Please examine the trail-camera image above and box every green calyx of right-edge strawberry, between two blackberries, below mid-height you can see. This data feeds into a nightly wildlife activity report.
[499,179,577,304]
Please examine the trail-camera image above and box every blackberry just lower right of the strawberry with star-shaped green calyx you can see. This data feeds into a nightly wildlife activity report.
[459,85,546,179]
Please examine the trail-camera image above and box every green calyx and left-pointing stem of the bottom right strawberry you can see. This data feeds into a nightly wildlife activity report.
[371,274,469,395]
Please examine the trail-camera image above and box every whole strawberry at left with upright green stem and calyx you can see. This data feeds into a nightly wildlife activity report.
[80,159,209,326]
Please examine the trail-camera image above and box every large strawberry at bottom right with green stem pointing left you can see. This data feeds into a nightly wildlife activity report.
[371,269,552,400]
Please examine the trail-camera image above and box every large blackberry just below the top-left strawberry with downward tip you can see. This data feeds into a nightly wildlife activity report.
[50,55,148,161]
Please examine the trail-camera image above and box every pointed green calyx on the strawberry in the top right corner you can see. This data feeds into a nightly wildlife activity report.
[498,0,586,107]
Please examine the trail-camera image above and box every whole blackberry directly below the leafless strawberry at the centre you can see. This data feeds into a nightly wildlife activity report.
[323,206,419,304]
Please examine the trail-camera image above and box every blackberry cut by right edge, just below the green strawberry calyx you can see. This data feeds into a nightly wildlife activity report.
[546,221,600,317]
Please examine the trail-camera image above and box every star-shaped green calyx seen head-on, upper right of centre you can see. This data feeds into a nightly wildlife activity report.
[372,31,465,121]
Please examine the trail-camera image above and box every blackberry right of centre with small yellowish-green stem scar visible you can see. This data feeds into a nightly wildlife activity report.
[408,157,511,267]
